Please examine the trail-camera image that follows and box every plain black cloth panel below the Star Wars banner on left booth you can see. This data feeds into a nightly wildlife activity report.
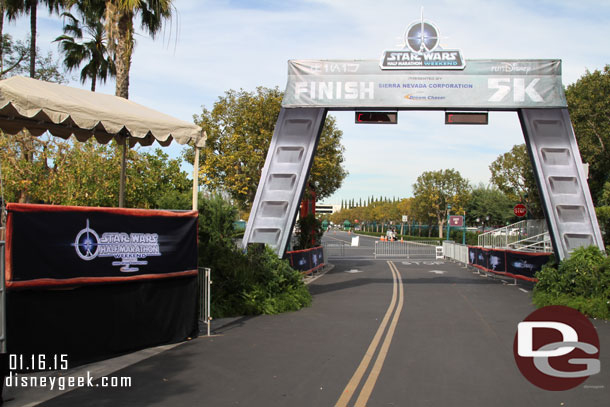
[6,276,200,373]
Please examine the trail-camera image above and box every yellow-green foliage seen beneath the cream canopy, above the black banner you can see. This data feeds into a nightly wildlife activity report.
[0,134,190,209]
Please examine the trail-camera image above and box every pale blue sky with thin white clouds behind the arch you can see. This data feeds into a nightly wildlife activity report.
[4,0,610,204]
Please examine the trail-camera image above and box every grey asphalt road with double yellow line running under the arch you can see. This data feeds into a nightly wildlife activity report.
[35,260,610,407]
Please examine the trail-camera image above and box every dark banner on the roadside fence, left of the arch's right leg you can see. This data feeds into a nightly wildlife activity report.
[468,246,551,281]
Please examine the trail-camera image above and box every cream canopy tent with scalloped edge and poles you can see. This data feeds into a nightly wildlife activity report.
[0,76,206,210]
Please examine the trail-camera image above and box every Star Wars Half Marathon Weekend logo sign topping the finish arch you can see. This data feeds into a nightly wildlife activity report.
[379,17,466,70]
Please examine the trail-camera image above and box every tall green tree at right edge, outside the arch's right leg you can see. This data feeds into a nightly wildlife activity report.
[566,65,610,204]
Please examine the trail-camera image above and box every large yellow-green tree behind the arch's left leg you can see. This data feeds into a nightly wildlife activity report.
[192,87,350,210]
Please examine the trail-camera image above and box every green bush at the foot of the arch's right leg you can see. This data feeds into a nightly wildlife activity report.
[533,246,610,319]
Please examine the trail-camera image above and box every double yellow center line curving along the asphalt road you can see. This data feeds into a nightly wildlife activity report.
[335,261,404,407]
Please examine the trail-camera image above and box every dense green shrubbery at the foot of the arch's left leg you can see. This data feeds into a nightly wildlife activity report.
[199,197,311,318]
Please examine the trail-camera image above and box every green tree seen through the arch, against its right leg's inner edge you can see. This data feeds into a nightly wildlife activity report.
[489,144,544,218]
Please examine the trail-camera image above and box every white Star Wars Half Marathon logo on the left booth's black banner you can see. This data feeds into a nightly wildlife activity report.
[72,219,161,273]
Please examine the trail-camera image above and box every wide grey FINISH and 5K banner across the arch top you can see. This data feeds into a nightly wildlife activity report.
[282,59,567,110]
